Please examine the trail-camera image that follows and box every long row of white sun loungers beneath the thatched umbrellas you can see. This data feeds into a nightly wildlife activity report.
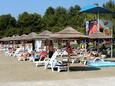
[3,48,106,72]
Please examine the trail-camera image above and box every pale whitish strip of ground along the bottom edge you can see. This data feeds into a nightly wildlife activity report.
[0,77,115,86]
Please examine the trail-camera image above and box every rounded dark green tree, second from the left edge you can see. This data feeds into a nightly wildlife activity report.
[18,12,43,32]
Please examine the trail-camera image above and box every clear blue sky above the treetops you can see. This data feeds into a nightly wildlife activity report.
[0,0,109,18]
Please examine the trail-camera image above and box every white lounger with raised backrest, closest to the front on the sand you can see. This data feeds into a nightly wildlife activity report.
[45,51,67,72]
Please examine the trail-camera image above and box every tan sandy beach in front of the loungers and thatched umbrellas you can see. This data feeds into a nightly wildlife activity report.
[0,52,115,86]
